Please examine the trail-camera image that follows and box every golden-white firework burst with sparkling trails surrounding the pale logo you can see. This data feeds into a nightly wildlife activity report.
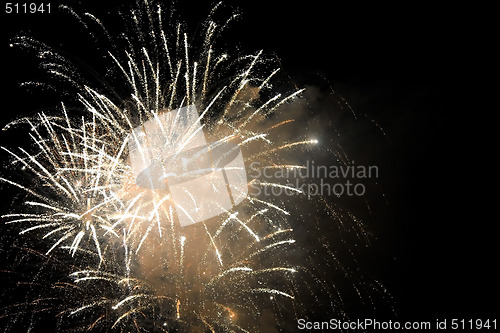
[1,0,390,332]
